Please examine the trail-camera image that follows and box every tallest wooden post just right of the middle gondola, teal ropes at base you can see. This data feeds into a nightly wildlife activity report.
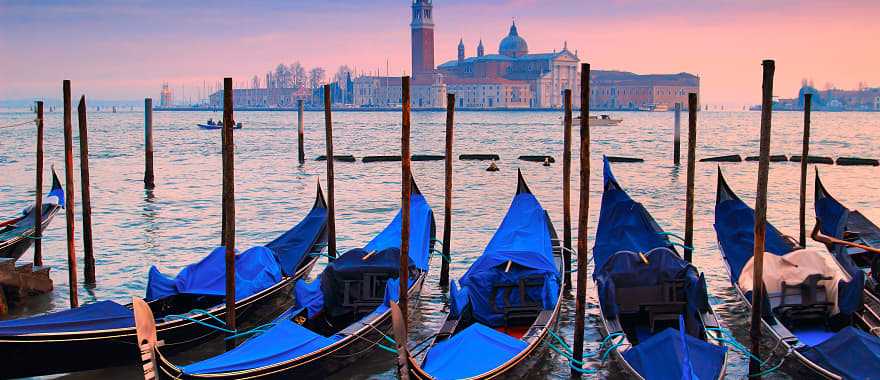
[571,63,590,378]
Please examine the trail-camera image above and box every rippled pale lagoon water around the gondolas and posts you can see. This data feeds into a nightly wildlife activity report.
[0,110,880,378]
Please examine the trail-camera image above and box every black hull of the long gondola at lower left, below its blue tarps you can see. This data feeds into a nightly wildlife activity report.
[0,257,318,378]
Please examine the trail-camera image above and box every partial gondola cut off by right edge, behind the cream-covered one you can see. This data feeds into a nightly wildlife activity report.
[813,169,880,296]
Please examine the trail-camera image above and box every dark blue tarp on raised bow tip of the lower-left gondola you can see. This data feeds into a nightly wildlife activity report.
[266,202,327,276]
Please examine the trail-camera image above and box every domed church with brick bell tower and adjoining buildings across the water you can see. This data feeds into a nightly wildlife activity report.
[353,0,699,109]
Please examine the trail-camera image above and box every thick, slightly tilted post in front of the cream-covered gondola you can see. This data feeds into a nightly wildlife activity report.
[749,60,776,378]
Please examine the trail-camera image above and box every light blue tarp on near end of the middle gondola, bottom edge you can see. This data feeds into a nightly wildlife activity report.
[422,323,528,380]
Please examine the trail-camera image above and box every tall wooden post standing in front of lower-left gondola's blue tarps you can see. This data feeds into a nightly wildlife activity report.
[222,78,236,349]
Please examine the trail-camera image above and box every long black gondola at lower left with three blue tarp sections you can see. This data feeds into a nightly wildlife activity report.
[0,186,327,378]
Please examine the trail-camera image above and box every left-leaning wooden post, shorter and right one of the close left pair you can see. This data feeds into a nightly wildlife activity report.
[76,95,96,285]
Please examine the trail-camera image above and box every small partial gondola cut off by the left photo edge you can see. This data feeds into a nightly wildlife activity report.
[0,170,64,260]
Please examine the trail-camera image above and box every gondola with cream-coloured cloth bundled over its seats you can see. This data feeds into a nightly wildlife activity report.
[715,168,880,379]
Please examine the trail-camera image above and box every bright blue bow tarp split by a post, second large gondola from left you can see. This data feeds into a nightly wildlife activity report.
[364,193,434,270]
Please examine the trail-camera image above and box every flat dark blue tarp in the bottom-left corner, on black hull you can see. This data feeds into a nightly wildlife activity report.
[0,301,134,334]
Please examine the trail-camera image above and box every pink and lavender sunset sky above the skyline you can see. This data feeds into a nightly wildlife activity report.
[0,0,880,105]
